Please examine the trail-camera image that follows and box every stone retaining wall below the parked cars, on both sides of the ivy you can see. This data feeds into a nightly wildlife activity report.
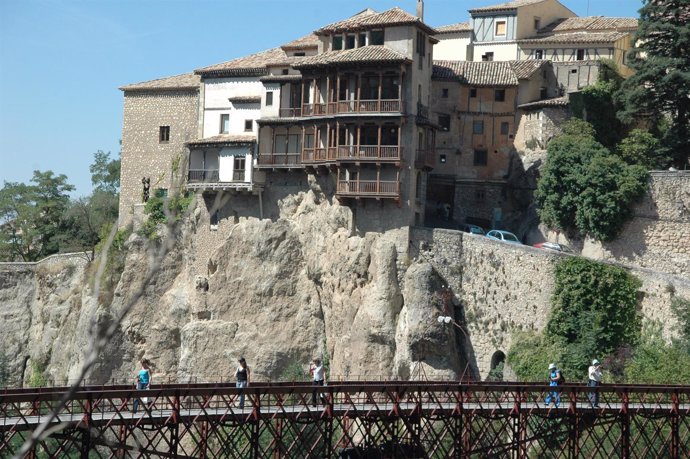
[410,228,690,378]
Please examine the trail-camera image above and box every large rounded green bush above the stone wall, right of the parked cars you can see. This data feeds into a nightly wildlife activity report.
[535,126,647,240]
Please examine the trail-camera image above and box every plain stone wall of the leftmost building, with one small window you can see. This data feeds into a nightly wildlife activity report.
[119,90,199,227]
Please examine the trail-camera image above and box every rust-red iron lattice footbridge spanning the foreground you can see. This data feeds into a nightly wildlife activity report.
[0,381,690,459]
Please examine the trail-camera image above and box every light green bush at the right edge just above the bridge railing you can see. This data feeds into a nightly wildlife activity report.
[625,323,690,384]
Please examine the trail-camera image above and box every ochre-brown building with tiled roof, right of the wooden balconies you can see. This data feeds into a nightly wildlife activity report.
[427,60,559,228]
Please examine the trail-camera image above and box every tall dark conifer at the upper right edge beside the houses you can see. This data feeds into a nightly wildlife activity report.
[617,0,690,167]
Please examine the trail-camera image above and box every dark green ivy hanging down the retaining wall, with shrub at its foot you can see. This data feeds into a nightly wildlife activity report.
[508,257,641,382]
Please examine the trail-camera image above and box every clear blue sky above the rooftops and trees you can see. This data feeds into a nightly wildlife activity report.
[0,0,642,197]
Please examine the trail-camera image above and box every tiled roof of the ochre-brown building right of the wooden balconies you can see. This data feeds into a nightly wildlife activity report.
[432,61,518,86]
